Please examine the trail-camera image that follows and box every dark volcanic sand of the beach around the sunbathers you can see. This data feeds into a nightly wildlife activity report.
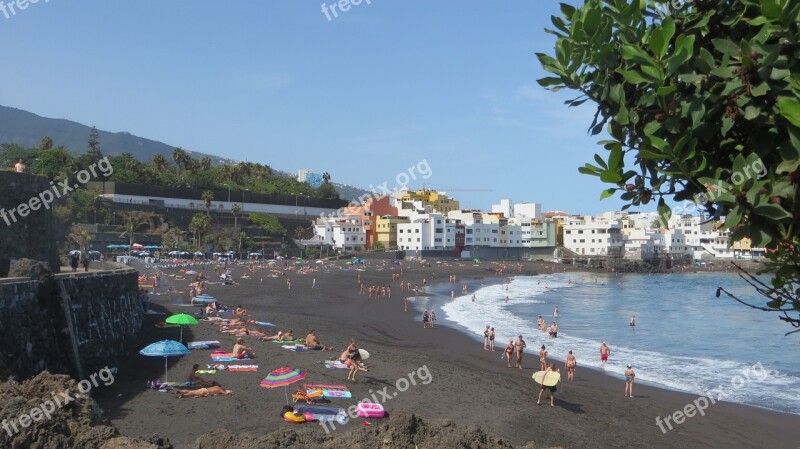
[95,262,800,449]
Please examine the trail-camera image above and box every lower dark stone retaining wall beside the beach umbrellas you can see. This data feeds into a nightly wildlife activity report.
[0,269,143,379]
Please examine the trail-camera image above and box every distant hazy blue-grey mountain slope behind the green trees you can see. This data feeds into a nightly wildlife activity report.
[0,106,229,162]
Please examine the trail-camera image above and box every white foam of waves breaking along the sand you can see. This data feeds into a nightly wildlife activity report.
[442,273,800,414]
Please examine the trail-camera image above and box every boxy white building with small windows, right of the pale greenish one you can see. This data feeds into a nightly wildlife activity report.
[563,217,625,256]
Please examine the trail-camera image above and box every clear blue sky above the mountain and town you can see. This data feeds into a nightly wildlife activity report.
[0,0,656,213]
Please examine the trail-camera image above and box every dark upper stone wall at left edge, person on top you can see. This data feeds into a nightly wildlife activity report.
[0,171,60,277]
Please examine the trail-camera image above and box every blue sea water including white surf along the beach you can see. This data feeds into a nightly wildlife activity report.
[428,272,800,414]
